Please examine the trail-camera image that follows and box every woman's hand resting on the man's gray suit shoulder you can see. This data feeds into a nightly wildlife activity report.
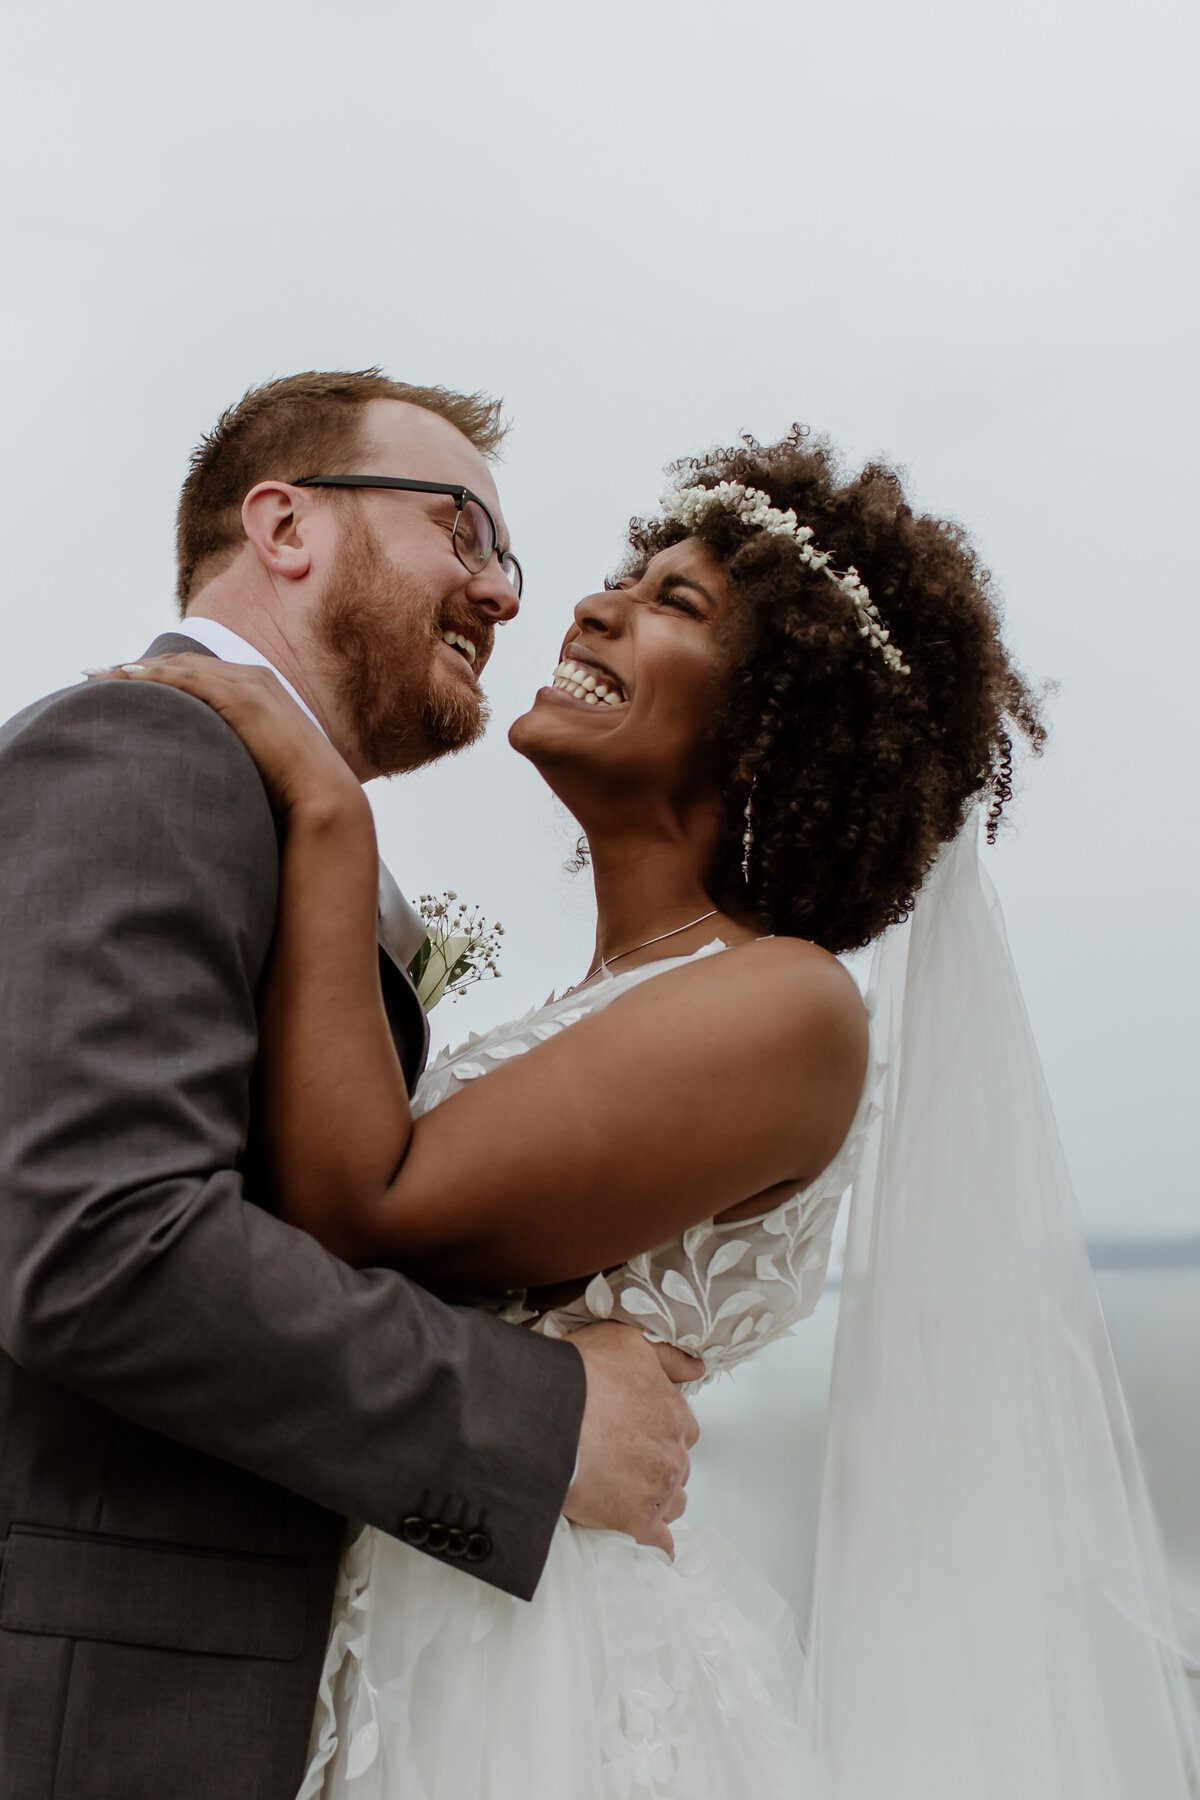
[86,652,365,815]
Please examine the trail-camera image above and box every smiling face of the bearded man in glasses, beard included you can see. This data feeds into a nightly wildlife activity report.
[313,400,516,774]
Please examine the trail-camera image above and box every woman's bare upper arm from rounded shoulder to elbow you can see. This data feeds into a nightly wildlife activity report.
[367,938,867,1289]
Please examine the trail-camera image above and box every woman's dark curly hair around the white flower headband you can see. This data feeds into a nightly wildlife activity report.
[628,427,1045,952]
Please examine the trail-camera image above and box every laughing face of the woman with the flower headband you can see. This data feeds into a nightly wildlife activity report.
[509,538,734,814]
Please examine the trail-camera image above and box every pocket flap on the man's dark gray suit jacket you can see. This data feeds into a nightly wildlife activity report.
[0,1525,308,1661]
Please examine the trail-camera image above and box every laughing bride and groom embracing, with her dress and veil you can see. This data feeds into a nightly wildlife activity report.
[0,373,1195,1800]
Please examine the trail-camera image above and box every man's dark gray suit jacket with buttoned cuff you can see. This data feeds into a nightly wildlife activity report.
[0,641,585,1800]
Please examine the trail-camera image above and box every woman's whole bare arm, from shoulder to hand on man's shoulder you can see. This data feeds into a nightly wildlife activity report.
[89,657,867,1289]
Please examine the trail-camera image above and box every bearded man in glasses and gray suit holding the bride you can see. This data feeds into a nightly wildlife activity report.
[0,371,694,1800]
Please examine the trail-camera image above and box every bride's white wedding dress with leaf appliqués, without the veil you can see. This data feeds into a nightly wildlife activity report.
[299,940,878,1800]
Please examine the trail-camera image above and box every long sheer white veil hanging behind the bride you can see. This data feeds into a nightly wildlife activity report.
[804,815,1200,1800]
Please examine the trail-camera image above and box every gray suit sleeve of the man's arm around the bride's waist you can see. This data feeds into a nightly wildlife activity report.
[0,682,585,1597]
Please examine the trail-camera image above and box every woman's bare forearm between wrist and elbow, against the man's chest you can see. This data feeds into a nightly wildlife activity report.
[257,790,412,1255]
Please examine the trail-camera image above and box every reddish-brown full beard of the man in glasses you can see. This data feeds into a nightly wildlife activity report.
[313,522,488,776]
